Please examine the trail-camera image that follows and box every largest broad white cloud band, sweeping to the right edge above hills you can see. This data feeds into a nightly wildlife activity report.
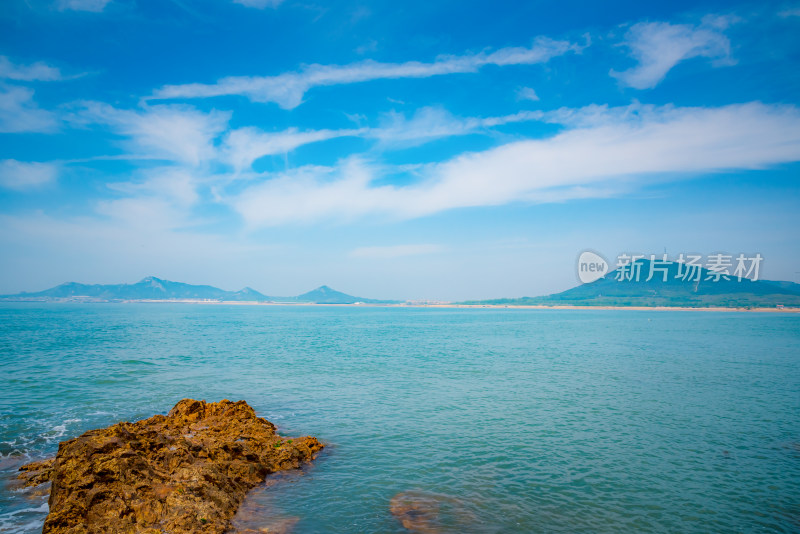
[229,102,800,227]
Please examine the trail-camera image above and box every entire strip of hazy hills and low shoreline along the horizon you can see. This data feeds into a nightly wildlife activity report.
[0,259,800,309]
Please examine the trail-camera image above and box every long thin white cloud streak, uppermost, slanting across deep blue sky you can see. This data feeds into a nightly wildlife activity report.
[147,37,581,109]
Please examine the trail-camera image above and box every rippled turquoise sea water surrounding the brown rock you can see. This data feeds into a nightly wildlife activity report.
[0,304,800,533]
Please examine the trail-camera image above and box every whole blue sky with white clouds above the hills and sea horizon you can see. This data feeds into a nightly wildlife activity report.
[0,0,800,300]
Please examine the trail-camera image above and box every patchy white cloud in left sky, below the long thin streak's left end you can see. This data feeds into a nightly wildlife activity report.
[78,102,231,166]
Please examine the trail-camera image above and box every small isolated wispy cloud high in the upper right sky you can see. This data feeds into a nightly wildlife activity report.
[610,16,734,89]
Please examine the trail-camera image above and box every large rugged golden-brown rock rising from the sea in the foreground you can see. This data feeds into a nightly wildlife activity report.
[20,399,323,534]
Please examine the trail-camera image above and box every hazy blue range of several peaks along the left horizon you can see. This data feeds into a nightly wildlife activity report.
[0,276,393,304]
